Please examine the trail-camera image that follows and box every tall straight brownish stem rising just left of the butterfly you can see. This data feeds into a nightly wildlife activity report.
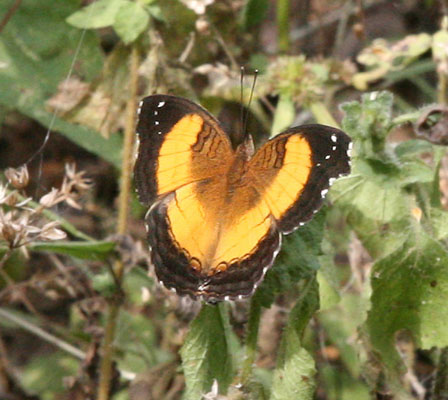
[97,44,139,400]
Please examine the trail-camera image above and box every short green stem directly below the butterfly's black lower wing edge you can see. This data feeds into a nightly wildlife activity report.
[239,296,261,386]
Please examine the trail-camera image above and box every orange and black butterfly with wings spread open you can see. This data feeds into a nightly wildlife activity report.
[135,95,351,302]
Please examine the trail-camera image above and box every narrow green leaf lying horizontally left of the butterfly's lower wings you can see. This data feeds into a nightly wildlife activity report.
[29,241,115,260]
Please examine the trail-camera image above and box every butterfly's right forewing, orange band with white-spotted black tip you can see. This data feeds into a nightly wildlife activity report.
[249,125,351,233]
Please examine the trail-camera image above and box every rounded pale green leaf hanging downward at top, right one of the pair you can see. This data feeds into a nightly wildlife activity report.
[113,1,149,44]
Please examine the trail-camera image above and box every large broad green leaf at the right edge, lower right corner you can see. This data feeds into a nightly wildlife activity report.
[366,229,448,382]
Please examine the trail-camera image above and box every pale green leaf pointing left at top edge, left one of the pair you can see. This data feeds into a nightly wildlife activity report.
[67,0,127,29]
